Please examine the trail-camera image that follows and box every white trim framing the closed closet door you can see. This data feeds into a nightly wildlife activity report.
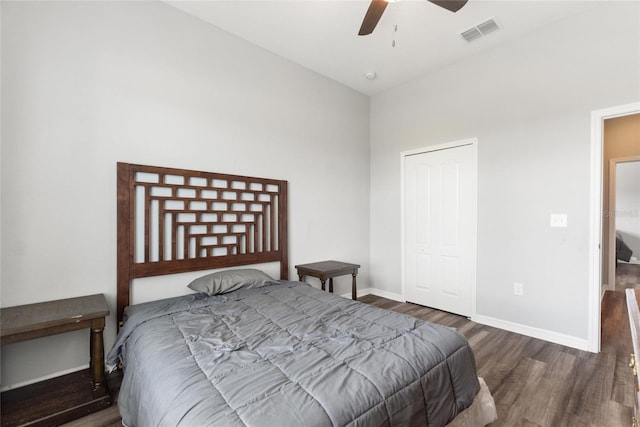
[400,138,478,319]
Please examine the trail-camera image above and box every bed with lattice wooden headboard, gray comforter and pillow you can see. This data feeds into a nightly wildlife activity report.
[107,163,495,427]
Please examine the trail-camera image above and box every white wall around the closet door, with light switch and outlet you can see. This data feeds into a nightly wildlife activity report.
[370,2,640,344]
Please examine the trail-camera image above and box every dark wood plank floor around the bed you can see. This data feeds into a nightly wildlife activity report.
[61,264,640,427]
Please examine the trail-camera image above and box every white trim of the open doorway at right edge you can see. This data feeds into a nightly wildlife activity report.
[588,102,640,353]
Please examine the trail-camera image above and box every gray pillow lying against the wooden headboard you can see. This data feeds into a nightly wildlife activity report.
[187,268,273,295]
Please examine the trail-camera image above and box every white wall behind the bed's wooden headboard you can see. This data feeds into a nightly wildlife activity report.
[1,1,369,388]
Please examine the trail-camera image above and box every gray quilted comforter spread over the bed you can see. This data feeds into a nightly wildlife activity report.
[107,282,479,427]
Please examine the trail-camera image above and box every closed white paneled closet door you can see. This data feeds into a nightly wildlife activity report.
[404,144,476,316]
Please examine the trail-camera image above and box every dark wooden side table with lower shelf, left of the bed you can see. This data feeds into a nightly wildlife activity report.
[0,294,112,426]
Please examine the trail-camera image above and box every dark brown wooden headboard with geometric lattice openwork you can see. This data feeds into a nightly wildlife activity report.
[117,163,289,324]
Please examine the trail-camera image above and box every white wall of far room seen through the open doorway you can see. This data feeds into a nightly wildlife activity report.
[616,161,640,259]
